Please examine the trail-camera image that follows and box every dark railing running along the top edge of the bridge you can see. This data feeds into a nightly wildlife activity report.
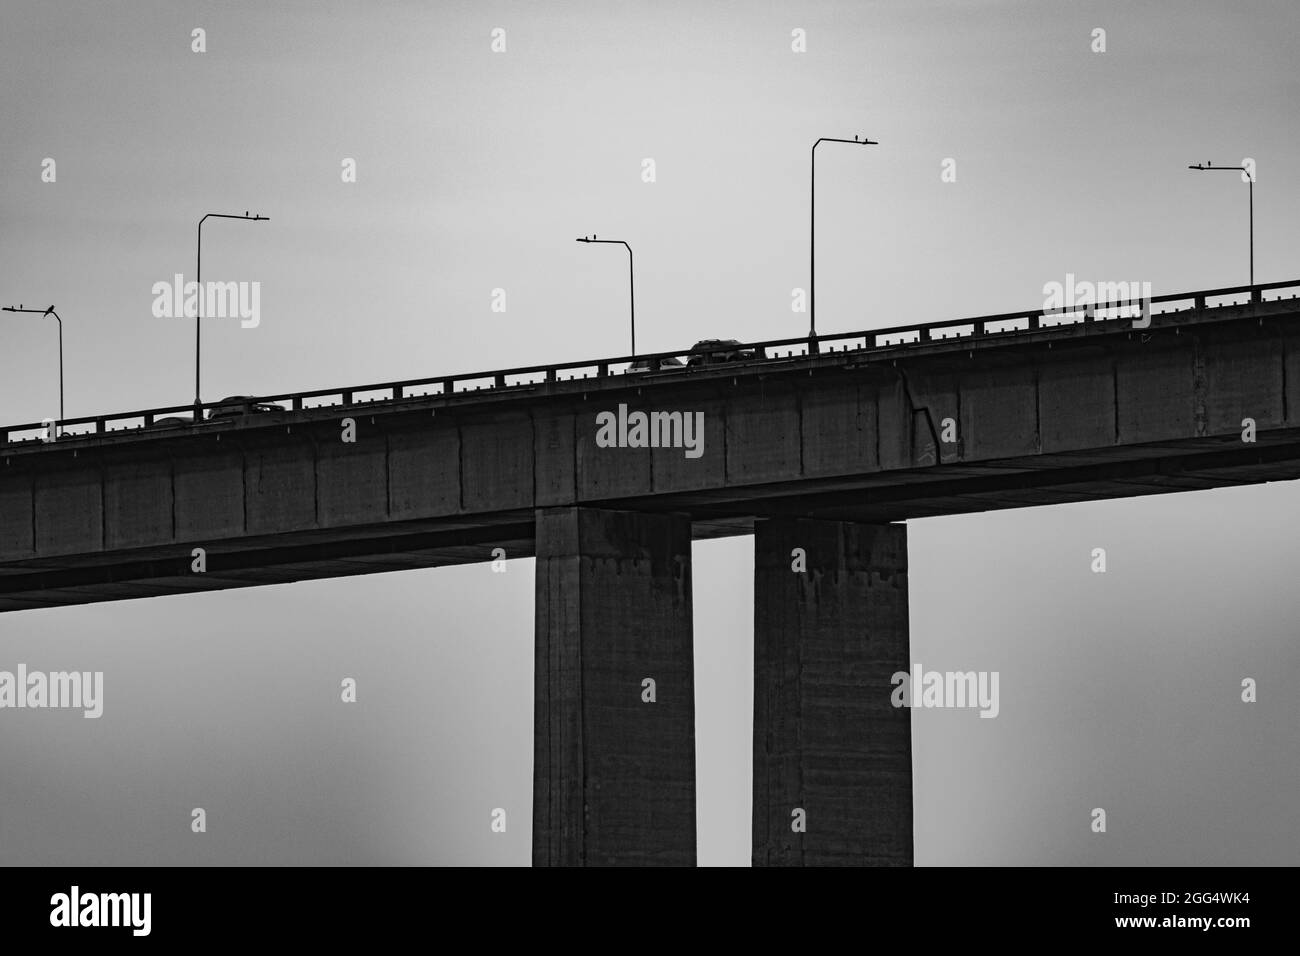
[0,280,1300,446]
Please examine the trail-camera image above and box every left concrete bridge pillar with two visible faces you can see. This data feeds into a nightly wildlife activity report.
[533,509,696,866]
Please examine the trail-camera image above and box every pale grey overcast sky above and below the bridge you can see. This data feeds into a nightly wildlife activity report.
[0,0,1300,865]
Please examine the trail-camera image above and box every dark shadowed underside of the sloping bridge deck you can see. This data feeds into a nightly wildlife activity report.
[0,429,1300,611]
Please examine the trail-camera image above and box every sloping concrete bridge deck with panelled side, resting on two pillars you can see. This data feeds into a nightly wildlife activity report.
[0,284,1300,610]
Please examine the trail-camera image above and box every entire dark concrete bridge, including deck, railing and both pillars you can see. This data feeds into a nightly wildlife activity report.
[0,281,1300,865]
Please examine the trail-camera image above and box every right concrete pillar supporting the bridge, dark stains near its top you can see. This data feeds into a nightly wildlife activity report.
[753,519,913,866]
